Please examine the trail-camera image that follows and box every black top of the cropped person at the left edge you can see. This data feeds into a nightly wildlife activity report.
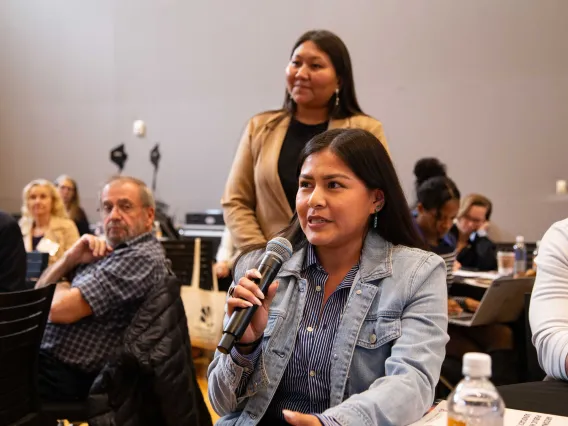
[0,211,27,292]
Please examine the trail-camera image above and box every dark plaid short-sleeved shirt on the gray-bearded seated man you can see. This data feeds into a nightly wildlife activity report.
[41,233,167,372]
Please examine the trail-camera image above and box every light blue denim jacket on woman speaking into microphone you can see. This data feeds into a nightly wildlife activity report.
[208,232,448,426]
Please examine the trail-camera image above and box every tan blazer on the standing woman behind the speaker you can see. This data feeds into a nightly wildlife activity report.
[221,111,388,249]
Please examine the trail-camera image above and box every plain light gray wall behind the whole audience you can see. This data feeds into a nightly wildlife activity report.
[0,0,568,240]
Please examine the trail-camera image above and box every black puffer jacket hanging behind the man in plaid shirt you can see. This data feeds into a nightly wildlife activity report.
[89,275,212,426]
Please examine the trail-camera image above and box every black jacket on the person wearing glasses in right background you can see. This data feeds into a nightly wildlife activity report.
[450,225,497,271]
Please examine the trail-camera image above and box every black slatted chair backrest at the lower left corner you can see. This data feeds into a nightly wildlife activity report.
[0,285,55,425]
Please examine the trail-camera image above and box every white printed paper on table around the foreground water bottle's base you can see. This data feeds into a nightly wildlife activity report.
[410,401,568,426]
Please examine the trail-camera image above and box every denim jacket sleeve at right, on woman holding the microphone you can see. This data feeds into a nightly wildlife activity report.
[323,254,449,425]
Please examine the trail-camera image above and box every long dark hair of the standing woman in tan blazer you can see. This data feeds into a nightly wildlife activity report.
[282,30,364,118]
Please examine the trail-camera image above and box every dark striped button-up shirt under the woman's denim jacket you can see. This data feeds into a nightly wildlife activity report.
[231,244,359,426]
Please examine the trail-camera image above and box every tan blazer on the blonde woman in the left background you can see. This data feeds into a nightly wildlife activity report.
[20,217,79,265]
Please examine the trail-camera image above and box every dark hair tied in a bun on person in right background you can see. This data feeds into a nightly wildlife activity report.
[414,158,461,213]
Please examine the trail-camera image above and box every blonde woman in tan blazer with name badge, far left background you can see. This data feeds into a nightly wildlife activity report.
[20,179,79,265]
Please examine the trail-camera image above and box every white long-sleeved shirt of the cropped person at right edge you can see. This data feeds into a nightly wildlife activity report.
[529,219,568,380]
